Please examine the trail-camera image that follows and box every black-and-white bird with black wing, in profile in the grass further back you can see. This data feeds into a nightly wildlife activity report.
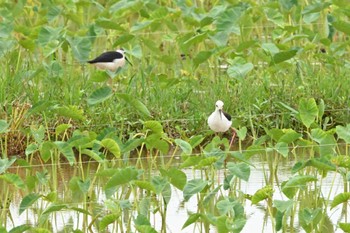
[88,49,131,72]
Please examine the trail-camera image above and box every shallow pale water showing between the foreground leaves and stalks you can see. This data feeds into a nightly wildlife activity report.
[2,158,343,233]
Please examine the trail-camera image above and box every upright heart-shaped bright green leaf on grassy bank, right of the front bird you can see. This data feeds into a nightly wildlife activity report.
[299,98,318,128]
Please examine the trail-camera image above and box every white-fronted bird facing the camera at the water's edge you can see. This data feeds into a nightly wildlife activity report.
[208,100,236,146]
